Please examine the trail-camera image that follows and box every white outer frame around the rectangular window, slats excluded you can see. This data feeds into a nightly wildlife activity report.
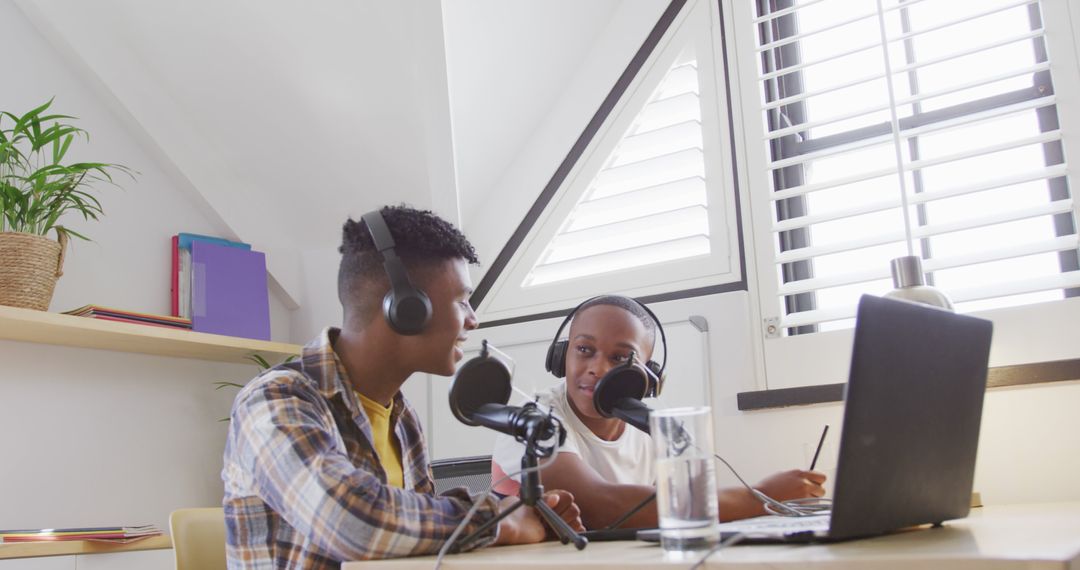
[718,0,1080,390]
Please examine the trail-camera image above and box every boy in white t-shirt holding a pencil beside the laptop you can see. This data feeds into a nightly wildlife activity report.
[491,295,825,529]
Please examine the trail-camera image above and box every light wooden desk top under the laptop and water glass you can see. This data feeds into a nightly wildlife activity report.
[341,503,1080,570]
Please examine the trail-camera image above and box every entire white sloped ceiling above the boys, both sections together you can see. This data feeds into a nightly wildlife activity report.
[16,0,656,306]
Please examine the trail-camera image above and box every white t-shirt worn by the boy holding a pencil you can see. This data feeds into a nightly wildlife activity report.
[491,382,657,485]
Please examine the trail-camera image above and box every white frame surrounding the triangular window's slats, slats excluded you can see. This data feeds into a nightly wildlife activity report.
[471,0,746,326]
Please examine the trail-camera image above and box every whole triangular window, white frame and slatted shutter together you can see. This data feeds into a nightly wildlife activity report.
[478,0,744,322]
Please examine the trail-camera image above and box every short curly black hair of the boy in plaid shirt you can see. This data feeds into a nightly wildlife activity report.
[338,204,478,318]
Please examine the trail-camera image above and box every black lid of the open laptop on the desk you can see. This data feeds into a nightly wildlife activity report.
[828,295,993,539]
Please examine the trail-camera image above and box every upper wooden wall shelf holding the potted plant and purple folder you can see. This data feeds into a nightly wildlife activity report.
[0,307,302,363]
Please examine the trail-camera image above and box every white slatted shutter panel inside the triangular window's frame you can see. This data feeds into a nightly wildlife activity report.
[522,50,710,288]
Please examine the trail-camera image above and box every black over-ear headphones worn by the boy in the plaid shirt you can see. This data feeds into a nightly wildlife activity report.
[363,209,431,335]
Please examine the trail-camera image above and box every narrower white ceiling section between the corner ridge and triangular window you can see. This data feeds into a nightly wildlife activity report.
[444,0,633,219]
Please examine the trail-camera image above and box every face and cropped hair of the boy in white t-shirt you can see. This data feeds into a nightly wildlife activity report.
[566,304,652,419]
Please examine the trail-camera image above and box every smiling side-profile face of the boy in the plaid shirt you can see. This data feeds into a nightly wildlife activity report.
[405,258,480,376]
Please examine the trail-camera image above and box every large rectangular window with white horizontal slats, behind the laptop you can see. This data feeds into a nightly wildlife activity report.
[738,0,1080,335]
